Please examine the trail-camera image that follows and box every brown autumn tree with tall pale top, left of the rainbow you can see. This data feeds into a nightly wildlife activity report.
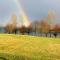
[5,15,17,33]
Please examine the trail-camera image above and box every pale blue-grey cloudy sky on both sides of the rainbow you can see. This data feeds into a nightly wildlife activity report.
[0,0,60,25]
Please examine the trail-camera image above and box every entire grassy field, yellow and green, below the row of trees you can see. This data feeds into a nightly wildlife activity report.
[0,34,60,60]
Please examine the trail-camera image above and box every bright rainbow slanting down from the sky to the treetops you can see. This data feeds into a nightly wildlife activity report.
[14,0,30,27]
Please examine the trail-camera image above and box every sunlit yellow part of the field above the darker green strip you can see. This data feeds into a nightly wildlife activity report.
[0,34,60,56]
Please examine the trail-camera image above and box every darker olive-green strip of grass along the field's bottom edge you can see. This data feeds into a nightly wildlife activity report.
[0,53,60,60]
